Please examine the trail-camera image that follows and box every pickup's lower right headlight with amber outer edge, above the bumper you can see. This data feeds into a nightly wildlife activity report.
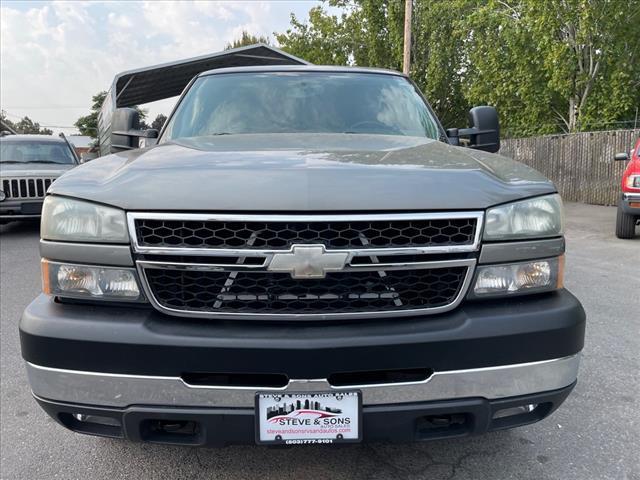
[470,256,564,298]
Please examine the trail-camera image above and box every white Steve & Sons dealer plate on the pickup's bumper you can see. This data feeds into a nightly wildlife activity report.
[256,391,362,445]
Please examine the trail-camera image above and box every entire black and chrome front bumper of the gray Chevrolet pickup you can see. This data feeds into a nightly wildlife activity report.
[20,290,585,445]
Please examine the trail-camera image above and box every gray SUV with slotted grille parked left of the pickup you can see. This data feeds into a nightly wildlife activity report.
[0,135,79,224]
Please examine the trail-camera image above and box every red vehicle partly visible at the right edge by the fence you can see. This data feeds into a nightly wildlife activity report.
[615,138,640,238]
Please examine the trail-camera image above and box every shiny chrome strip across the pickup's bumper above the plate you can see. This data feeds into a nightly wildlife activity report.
[27,354,580,408]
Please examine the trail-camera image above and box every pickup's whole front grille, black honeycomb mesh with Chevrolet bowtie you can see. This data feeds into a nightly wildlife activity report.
[128,212,483,320]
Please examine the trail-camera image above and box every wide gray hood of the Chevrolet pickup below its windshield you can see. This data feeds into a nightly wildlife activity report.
[50,134,555,212]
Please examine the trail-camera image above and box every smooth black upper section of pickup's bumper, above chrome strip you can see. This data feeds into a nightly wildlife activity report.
[20,290,585,379]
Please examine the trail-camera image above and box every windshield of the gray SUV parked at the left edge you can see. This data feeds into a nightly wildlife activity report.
[0,139,75,165]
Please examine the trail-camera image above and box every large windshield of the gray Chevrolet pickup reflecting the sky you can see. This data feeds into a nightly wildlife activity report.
[163,72,439,140]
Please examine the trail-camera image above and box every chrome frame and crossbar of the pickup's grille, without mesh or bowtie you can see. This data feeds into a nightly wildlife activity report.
[128,212,484,320]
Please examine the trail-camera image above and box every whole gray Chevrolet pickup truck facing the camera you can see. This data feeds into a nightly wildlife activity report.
[20,66,585,445]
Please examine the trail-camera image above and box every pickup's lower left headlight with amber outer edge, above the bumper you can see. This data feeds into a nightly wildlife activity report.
[42,259,144,302]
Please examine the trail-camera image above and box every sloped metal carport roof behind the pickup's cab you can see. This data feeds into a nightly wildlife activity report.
[109,43,309,108]
